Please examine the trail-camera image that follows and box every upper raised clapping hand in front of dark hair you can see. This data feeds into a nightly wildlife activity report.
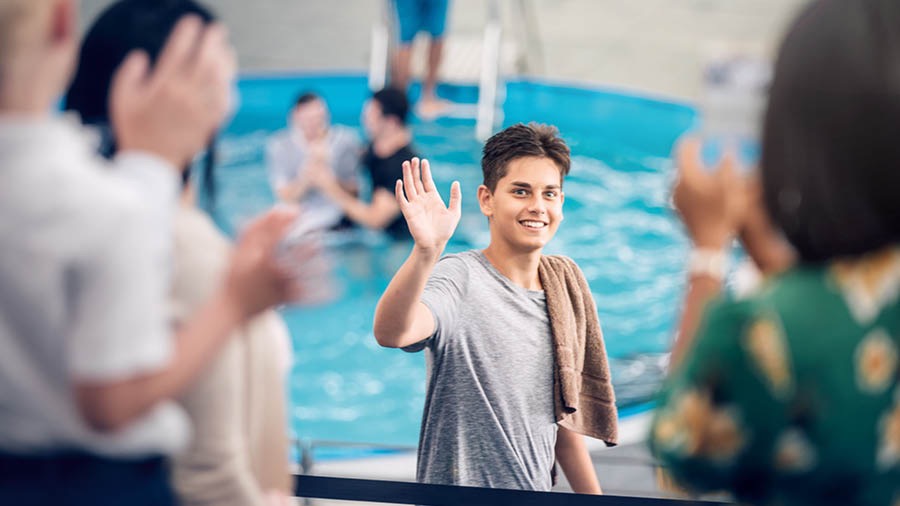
[110,15,237,169]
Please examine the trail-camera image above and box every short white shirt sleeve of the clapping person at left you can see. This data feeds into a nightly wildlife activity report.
[67,200,173,381]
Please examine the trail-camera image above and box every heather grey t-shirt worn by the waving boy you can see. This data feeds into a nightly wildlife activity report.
[405,251,557,490]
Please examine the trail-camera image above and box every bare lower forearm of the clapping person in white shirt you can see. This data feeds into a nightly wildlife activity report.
[77,294,244,431]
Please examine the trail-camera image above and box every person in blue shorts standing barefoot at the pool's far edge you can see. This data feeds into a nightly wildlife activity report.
[391,0,450,119]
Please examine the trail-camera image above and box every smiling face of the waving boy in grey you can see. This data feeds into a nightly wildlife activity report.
[478,156,565,253]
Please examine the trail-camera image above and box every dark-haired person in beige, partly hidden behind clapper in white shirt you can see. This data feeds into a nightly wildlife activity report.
[66,0,296,506]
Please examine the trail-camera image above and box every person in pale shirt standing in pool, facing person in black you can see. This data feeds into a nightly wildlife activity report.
[266,92,362,228]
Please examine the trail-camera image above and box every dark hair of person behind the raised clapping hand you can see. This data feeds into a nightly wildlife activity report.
[65,0,215,199]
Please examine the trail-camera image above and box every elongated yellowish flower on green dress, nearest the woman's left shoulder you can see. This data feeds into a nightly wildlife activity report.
[744,315,793,397]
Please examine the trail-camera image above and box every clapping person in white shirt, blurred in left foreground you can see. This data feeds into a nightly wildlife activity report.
[0,0,295,505]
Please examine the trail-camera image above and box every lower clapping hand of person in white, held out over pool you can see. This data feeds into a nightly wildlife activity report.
[225,208,297,318]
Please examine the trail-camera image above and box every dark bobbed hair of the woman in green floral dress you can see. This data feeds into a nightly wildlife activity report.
[761,0,900,262]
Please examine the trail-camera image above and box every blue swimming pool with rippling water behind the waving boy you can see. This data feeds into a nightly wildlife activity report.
[209,75,695,445]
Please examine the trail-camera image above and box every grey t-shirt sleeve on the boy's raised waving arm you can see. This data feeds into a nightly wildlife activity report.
[403,256,469,352]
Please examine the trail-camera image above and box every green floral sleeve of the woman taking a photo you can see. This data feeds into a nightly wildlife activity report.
[649,301,781,496]
